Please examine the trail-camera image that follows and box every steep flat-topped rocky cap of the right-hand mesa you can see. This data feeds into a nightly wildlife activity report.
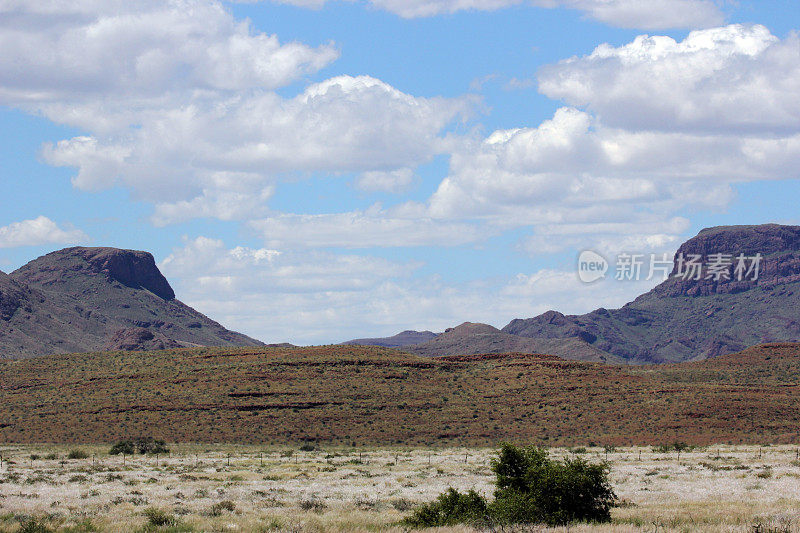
[648,224,800,300]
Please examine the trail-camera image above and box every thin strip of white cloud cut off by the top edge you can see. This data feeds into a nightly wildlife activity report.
[260,0,725,30]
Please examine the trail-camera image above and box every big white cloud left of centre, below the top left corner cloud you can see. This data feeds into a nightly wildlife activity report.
[43,76,471,206]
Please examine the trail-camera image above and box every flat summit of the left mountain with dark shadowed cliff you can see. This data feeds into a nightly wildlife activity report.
[12,247,175,300]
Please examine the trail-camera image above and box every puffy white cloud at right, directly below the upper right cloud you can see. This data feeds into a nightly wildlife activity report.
[430,108,800,226]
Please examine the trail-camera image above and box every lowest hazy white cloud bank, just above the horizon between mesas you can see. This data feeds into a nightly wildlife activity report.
[159,237,647,344]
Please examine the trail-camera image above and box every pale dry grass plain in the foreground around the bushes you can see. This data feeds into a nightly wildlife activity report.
[0,446,800,532]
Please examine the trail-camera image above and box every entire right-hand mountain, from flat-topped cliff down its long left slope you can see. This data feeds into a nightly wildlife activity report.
[502,224,800,363]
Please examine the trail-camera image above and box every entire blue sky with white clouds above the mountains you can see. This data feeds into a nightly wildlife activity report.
[0,0,800,344]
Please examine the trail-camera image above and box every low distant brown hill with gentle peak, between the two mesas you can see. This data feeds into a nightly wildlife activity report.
[403,322,624,363]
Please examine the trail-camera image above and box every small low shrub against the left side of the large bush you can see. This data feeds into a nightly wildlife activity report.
[404,488,488,528]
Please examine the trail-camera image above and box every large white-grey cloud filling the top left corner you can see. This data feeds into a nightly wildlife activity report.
[0,0,338,105]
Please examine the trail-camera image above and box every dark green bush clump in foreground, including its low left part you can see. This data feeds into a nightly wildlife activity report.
[405,444,617,527]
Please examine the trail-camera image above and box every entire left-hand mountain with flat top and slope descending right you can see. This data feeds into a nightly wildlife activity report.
[0,247,261,359]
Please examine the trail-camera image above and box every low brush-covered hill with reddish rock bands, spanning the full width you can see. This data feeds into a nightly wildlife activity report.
[0,344,800,446]
